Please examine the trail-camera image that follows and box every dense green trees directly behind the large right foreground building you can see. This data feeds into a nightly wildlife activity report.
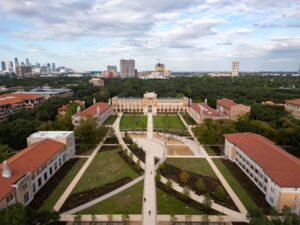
[194,104,300,156]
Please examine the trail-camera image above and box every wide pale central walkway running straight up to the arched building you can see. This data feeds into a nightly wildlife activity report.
[142,113,157,225]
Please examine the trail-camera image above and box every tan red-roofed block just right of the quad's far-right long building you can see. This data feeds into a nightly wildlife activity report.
[217,98,251,120]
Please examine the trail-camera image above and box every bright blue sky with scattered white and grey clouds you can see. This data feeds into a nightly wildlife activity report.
[0,0,300,71]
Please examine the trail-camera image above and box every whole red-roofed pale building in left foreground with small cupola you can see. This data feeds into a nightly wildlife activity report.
[0,132,75,208]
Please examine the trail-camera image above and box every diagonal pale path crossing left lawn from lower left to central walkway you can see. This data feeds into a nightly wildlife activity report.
[63,176,144,214]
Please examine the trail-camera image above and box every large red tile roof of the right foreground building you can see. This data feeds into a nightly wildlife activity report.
[224,133,300,187]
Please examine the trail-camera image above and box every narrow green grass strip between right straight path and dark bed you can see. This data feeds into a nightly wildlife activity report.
[213,159,257,209]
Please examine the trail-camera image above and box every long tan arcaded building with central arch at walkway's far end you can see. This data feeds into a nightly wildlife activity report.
[111,92,189,115]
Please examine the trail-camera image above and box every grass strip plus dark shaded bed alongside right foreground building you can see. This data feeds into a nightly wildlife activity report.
[213,159,270,213]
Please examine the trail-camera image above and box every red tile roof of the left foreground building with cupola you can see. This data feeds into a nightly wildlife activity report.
[0,139,65,199]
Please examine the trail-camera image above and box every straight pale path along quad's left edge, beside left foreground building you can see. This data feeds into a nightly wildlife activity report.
[53,137,106,211]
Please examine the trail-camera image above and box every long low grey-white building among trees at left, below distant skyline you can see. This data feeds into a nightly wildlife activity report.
[16,86,73,99]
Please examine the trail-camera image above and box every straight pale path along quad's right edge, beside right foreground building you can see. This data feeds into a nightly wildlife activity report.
[178,114,247,220]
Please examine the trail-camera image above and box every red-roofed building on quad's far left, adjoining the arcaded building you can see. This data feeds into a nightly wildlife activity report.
[72,99,113,126]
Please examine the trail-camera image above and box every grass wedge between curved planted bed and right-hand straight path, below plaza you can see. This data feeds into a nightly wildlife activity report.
[165,158,217,178]
